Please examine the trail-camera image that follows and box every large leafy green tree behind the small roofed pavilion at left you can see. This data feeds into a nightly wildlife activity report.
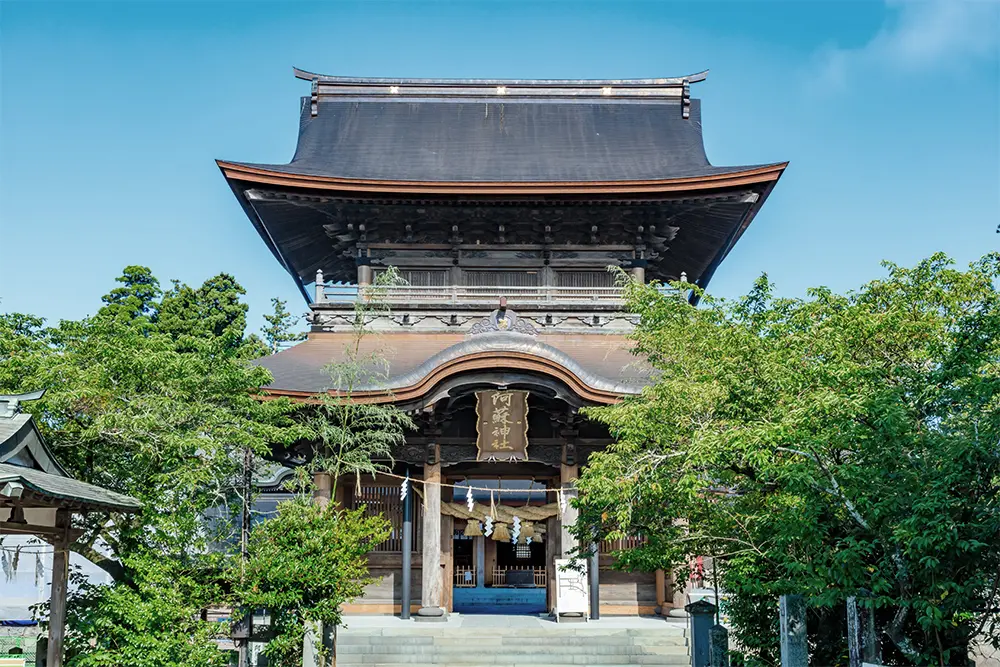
[0,267,309,665]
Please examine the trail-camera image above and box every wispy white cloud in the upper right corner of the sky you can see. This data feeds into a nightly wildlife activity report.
[818,0,1000,90]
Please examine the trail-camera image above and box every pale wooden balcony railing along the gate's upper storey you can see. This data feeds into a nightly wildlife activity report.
[316,285,623,306]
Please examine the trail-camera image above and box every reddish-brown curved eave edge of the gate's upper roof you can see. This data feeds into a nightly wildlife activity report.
[215,160,788,195]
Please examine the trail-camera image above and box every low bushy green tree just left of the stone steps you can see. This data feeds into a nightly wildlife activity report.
[228,494,390,667]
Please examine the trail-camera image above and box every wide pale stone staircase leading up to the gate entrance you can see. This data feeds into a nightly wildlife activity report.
[337,622,691,667]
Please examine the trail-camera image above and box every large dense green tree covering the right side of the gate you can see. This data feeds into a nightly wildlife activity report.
[576,255,1000,665]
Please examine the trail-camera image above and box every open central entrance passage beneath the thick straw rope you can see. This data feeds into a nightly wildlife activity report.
[452,480,548,614]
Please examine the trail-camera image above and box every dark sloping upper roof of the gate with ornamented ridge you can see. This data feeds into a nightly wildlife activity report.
[220,70,784,184]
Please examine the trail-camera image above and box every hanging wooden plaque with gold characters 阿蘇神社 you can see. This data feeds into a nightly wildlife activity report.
[476,391,528,461]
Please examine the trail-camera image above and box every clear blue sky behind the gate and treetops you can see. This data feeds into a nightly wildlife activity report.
[0,0,1000,328]
